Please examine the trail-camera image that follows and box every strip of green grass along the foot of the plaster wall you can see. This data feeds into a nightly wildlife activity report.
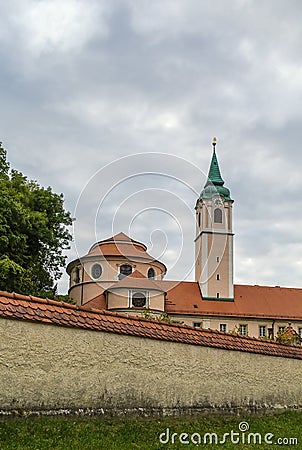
[0,411,302,450]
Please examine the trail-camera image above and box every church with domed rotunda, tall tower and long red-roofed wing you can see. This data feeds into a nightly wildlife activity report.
[67,138,302,339]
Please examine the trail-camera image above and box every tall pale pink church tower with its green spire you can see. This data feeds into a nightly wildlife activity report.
[195,138,234,301]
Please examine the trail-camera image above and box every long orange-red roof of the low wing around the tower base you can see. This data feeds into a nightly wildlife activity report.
[161,281,302,321]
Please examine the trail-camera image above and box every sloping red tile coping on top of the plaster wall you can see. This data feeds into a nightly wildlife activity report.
[0,292,302,359]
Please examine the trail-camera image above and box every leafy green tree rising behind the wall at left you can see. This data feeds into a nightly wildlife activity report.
[0,142,72,295]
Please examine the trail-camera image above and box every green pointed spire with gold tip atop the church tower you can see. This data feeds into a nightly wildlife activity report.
[199,137,231,200]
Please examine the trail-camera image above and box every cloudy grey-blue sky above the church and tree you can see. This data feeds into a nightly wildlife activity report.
[0,0,302,293]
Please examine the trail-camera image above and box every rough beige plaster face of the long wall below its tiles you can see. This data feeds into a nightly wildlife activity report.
[0,319,302,411]
